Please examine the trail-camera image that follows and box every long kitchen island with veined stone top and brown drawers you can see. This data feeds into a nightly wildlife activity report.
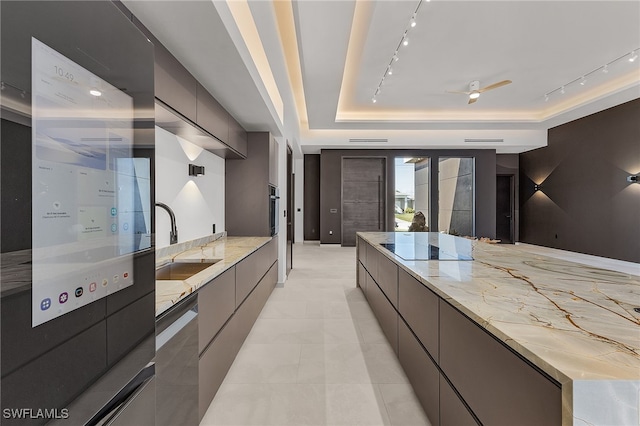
[357,233,640,425]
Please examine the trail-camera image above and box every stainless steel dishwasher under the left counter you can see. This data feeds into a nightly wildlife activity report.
[156,294,199,426]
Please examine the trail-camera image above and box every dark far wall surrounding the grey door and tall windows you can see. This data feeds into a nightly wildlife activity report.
[318,149,496,244]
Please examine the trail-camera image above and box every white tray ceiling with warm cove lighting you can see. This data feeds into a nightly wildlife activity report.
[123,0,640,152]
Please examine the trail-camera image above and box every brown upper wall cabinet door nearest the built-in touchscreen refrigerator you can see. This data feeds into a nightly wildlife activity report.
[154,44,196,122]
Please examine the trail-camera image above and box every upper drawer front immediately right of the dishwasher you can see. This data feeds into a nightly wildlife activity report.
[198,267,236,353]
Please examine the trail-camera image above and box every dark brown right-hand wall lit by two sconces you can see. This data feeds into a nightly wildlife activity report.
[520,99,640,262]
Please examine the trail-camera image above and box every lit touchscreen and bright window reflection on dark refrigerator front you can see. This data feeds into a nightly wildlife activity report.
[32,38,151,327]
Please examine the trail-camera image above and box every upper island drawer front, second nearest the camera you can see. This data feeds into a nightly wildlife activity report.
[398,269,439,361]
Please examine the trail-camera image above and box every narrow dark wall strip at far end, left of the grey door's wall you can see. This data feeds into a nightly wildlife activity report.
[304,154,320,241]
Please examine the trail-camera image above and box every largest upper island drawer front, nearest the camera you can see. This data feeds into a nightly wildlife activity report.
[440,300,562,426]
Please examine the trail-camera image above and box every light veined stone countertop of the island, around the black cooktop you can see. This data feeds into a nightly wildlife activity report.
[358,232,640,425]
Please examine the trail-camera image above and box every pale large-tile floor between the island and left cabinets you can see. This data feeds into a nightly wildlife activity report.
[200,243,430,426]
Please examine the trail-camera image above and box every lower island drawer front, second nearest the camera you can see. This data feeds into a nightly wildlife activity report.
[398,320,440,426]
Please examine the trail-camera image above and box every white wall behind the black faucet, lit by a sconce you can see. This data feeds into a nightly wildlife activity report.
[155,127,225,248]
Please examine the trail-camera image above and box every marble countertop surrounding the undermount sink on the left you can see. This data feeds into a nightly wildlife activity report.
[156,237,271,317]
